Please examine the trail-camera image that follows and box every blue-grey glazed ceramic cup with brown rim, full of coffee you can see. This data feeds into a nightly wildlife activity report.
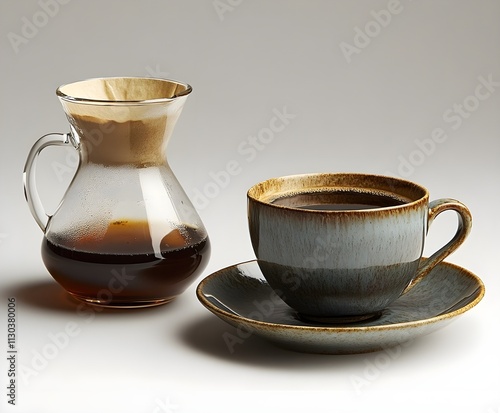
[247,173,472,323]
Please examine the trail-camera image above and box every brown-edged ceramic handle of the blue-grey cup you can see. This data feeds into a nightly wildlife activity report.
[403,198,472,294]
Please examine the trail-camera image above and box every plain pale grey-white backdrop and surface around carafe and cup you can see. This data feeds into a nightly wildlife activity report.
[0,0,500,413]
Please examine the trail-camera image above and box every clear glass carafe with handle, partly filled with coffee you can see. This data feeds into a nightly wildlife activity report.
[24,78,210,307]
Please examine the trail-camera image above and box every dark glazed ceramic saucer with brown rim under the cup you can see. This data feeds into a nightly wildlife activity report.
[196,260,484,354]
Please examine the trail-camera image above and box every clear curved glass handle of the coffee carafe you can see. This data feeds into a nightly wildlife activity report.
[23,133,79,232]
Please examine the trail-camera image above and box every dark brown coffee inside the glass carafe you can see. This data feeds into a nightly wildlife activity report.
[42,220,210,307]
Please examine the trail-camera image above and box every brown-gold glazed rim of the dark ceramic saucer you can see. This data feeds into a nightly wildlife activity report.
[196,257,486,333]
